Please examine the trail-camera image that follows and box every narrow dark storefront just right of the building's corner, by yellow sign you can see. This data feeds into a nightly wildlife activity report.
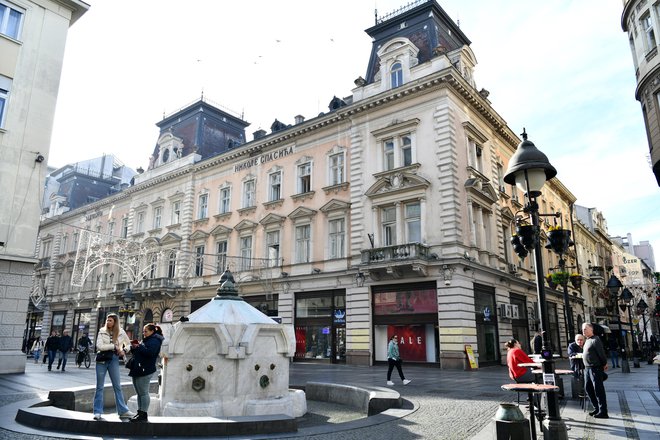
[474,284,500,367]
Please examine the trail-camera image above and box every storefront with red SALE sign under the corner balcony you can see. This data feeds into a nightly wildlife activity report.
[373,283,440,363]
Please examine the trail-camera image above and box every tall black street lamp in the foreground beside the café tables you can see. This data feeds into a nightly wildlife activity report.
[504,130,568,440]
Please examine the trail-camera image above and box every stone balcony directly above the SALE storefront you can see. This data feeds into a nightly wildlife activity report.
[360,243,436,280]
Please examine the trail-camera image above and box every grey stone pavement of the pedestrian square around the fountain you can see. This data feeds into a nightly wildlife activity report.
[0,360,660,440]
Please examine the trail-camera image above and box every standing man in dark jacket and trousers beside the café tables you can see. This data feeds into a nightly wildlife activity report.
[582,323,609,419]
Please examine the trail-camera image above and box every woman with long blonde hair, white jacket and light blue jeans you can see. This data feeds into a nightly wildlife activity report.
[94,313,135,420]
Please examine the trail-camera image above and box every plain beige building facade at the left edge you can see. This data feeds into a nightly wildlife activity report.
[0,0,88,373]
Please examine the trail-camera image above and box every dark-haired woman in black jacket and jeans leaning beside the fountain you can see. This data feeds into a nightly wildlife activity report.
[128,323,164,422]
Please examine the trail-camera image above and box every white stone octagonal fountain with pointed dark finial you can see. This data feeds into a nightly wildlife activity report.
[141,270,307,418]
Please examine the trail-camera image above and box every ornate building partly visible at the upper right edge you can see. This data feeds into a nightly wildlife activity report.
[621,0,660,186]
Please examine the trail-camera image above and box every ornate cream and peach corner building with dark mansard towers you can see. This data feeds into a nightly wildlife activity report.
[26,1,588,368]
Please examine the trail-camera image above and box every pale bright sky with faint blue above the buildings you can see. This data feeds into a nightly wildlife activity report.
[48,0,660,270]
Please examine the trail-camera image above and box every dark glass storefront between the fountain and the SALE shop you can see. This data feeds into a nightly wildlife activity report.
[294,290,346,363]
